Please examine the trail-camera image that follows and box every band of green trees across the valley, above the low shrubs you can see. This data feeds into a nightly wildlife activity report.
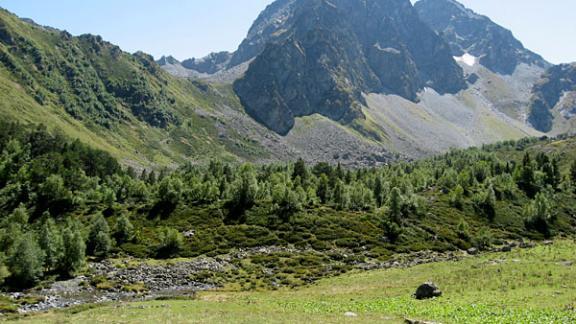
[0,122,576,286]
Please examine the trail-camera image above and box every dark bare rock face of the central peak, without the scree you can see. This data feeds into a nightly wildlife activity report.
[231,0,465,134]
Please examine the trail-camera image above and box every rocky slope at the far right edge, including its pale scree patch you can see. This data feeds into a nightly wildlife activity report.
[529,63,576,133]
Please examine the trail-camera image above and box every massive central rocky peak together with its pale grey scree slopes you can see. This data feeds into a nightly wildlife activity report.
[163,0,546,159]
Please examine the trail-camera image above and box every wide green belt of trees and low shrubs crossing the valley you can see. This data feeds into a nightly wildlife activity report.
[0,123,576,288]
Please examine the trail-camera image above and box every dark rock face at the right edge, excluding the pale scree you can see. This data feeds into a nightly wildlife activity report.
[528,63,576,132]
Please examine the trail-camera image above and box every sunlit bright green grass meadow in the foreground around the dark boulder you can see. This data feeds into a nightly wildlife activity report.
[13,240,576,323]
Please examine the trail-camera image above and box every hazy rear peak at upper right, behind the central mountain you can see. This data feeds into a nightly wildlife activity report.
[415,0,550,75]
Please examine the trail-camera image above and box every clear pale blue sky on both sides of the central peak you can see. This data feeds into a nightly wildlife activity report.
[0,0,576,63]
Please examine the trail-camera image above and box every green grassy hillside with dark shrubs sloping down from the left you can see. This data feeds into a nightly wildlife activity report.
[0,10,267,166]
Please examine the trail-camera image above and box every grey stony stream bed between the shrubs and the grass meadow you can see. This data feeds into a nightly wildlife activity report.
[4,242,547,314]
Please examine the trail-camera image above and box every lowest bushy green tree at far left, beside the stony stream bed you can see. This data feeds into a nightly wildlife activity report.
[8,234,44,287]
